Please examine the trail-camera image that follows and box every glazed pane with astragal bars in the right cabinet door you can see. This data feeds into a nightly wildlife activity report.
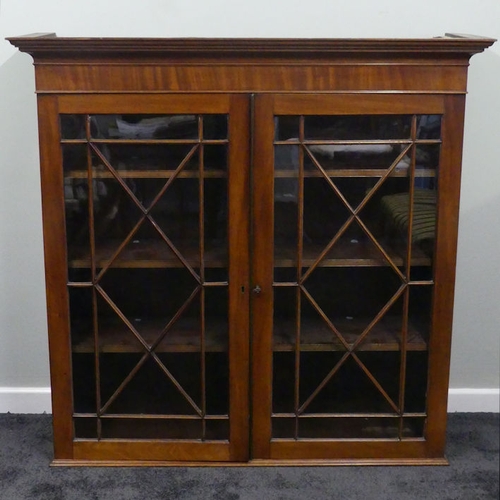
[270,109,441,441]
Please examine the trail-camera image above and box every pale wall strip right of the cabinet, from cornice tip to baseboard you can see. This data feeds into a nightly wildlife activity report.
[450,47,500,388]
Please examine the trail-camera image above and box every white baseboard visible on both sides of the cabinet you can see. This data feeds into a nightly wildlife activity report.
[0,387,500,413]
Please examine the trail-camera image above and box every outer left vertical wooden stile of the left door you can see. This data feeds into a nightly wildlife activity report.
[38,96,73,459]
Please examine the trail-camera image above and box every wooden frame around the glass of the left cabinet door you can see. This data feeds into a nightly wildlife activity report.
[38,93,250,464]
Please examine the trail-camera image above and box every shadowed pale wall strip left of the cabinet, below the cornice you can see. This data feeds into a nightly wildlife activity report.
[0,53,49,387]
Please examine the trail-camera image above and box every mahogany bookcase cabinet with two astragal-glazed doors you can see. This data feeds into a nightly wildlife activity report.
[10,34,494,465]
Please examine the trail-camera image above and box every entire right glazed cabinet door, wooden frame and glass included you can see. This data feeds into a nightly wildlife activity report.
[252,95,463,460]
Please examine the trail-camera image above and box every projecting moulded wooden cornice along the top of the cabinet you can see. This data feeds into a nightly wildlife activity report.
[7,33,495,59]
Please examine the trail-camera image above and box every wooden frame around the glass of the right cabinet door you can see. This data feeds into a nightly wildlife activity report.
[251,93,465,463]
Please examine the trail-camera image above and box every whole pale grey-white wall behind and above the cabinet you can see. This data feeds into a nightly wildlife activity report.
[0,0,500,412]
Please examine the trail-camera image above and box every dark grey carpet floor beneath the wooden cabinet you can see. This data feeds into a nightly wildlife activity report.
[0,413,499,500]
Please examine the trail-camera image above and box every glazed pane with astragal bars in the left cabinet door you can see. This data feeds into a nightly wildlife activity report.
[60,110,233,441]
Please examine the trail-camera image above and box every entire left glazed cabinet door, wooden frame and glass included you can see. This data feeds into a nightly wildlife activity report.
[40,95,249,461]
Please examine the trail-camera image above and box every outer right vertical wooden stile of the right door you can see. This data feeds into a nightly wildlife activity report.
[427,92,465,456]
